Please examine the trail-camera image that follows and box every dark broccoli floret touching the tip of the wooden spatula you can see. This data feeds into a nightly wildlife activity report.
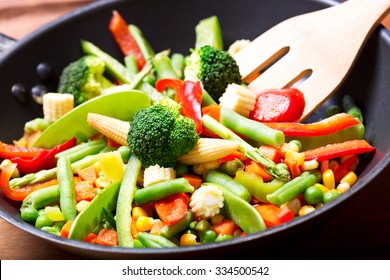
[185,45,242,101]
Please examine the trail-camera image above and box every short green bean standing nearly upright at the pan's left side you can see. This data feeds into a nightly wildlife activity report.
[57,157,77,221]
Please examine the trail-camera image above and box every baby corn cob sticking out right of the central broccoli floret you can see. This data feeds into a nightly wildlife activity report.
[177,138,240,165]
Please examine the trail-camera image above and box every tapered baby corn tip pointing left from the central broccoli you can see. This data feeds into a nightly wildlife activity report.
[87,113,130,146]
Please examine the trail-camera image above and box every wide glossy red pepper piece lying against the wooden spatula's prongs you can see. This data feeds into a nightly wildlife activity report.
[249,88,305,122]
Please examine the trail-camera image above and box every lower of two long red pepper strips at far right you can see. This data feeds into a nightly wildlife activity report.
[302,139,375,161]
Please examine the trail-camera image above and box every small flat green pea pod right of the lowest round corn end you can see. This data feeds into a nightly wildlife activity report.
[204,183,266,234]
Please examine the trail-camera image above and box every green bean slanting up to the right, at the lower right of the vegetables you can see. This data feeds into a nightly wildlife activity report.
[267,170,321,205]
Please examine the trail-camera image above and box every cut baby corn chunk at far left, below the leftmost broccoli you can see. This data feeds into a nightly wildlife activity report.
[42,92,74,121]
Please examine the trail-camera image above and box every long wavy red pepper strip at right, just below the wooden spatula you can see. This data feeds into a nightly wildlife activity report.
[264,113,360,136]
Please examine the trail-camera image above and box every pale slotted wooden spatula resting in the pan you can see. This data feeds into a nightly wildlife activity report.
[234,0,390,120]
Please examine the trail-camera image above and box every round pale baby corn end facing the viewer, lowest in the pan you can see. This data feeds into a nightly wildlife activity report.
[189,185,224,219]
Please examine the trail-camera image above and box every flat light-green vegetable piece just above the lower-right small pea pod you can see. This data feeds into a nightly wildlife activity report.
[234,170,286,203]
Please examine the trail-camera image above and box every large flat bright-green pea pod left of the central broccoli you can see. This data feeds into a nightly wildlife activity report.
[33,90,150,149]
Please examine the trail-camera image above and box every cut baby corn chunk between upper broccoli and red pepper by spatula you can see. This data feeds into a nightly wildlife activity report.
[219,84,256,117]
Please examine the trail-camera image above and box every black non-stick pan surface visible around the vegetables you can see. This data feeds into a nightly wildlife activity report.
[0,0,390,259]
